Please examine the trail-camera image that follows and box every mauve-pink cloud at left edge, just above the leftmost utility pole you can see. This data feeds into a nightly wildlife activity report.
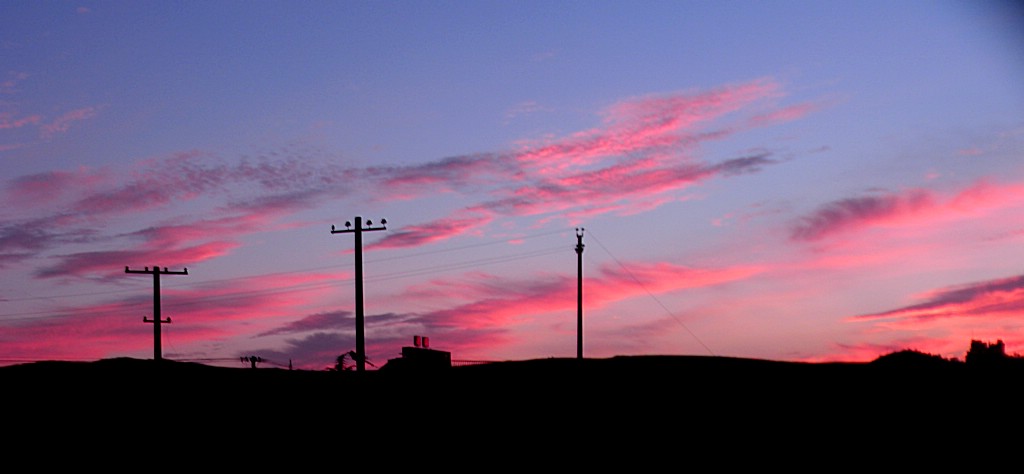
[0,153,360,277]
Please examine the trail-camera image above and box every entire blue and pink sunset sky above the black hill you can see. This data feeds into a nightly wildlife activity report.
[0,0,1024,370]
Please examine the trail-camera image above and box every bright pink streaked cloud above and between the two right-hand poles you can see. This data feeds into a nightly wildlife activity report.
[356,80,794,237]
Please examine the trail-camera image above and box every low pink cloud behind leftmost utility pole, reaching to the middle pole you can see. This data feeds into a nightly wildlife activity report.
[0,266,351,359]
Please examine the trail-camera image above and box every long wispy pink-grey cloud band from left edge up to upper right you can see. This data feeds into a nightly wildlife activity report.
[0,80,806,277]
